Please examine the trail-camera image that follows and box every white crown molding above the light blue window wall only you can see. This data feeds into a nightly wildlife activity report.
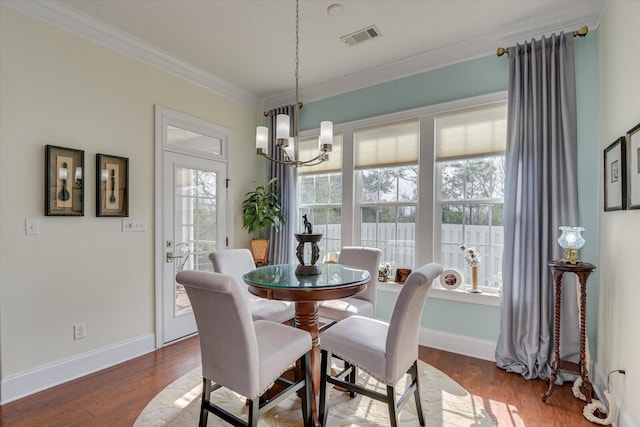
[261,2,606,109]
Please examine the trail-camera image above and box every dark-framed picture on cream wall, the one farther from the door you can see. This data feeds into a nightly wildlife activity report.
[44,145,84,216]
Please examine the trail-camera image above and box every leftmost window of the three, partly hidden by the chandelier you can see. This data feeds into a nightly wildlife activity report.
[298,135,342,260]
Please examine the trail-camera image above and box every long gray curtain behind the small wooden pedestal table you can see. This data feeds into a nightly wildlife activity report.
[496,33,580,381]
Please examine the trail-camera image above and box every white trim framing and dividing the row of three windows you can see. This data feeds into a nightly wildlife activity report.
[300,91,507,305]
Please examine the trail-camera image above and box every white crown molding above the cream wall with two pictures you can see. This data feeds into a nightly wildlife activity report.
[2,0,259,108]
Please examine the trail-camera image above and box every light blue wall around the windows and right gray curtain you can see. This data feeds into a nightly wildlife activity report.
[300,33,599,348]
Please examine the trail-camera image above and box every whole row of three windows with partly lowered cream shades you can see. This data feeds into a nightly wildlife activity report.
[298,92,507,302]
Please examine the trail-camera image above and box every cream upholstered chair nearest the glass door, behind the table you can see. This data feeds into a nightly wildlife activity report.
[209,249,295,323]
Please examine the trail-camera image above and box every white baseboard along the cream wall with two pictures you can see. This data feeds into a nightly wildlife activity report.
[0,334,155,405]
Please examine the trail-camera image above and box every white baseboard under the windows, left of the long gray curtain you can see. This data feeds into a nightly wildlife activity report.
[420,328,496,362]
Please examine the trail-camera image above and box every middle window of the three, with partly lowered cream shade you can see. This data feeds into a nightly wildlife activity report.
[354,119,420,271]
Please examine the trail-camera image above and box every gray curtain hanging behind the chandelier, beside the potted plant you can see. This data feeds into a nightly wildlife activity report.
[269,105,296,264]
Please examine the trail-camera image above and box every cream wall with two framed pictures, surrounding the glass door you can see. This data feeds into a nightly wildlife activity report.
[0,7,264,402]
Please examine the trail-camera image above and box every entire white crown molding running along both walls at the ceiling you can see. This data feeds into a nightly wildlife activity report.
[2,0,607,110]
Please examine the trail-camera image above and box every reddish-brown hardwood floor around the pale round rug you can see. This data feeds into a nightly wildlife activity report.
[0,337,597,427]
